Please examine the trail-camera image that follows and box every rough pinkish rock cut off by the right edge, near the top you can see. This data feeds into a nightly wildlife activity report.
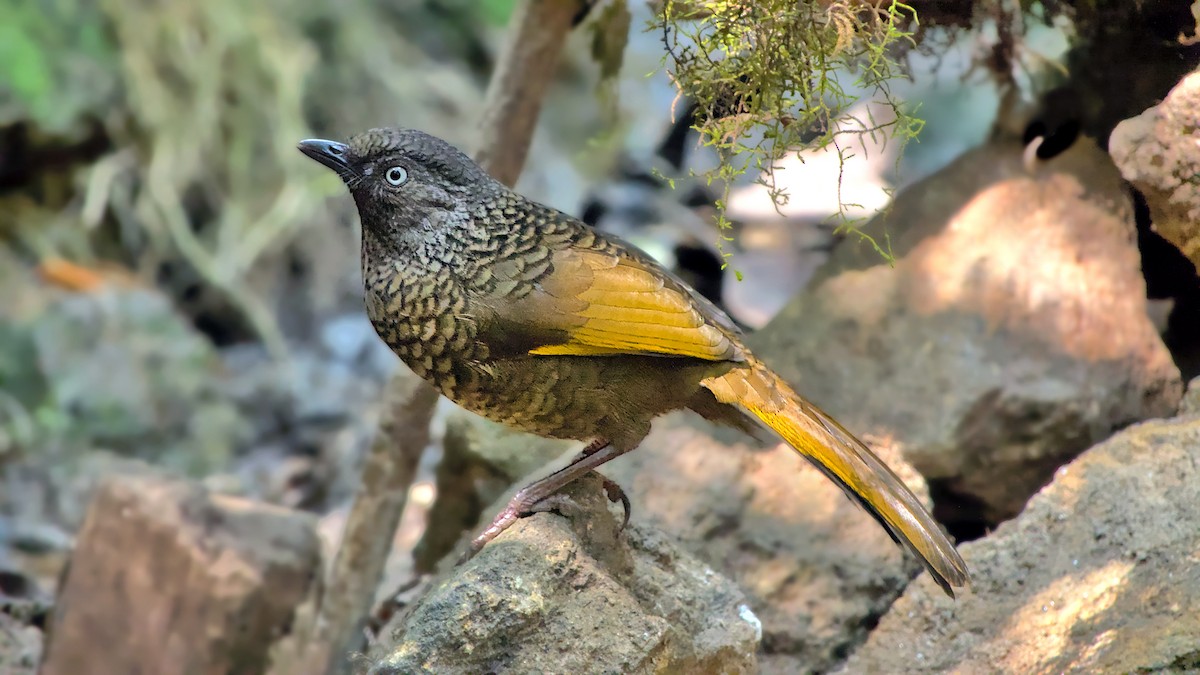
[1109,72,1200,269]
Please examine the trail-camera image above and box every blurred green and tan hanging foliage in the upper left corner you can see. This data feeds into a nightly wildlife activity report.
[0,0,511,350]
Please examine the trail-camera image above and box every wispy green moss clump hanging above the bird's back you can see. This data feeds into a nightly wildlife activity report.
[654,0,922,264]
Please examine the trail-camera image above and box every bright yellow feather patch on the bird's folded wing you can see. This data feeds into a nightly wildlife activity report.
[529,251,744,360]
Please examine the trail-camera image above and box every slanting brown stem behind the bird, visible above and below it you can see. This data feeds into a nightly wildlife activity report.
[306,0,584,675]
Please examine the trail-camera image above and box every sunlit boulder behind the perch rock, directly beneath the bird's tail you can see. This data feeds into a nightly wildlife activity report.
[604,414,929,674]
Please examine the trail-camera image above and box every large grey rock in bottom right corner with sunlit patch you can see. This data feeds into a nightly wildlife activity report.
[844,414,1200,674]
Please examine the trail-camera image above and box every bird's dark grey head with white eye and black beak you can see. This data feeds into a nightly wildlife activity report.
[299,129,502,233]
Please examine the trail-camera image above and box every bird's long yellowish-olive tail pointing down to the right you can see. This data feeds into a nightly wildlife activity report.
[701,357,970,598]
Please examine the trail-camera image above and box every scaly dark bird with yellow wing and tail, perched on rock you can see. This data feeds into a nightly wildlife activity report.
[299,127,970,598]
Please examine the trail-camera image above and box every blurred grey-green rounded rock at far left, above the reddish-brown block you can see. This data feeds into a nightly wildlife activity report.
[32,287,240,473]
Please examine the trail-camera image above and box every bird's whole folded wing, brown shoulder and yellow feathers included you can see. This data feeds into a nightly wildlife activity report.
[480,240,745,360]
